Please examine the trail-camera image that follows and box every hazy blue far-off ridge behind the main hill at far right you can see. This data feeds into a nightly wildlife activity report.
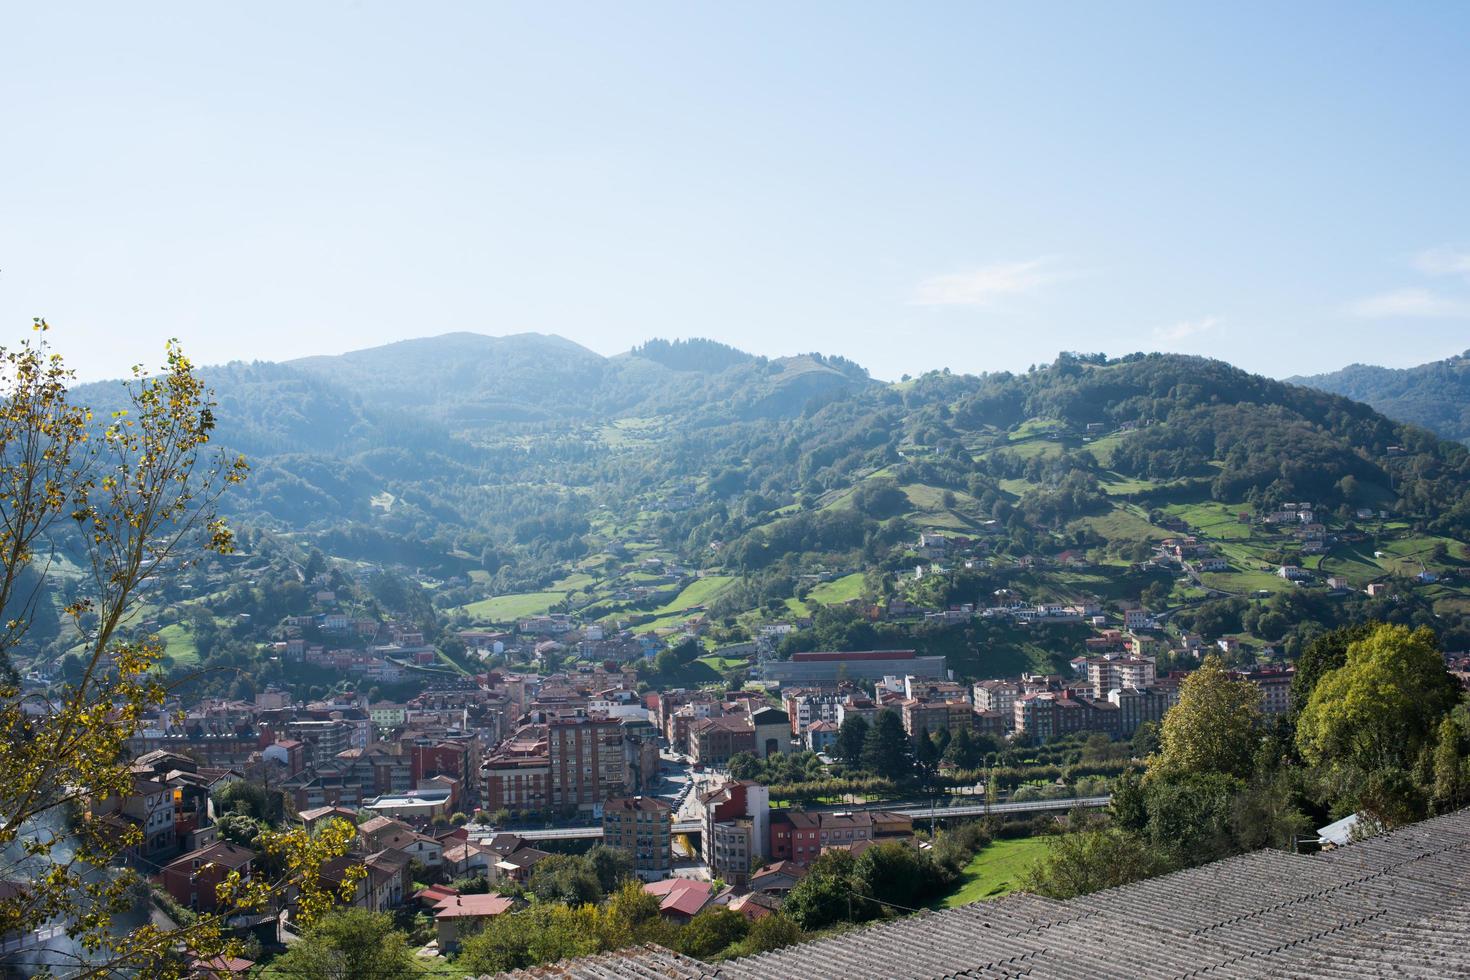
[1288,351,1470,445]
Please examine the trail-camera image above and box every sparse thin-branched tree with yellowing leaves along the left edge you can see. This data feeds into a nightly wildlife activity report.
[0,332,356,976]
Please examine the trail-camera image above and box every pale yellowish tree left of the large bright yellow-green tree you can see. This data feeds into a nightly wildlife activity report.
[1148,654,1261,779]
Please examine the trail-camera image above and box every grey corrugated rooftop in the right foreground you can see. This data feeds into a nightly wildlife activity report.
[485,810,1470,980]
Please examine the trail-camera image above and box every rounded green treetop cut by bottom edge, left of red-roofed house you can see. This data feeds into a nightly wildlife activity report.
[263,908,417,980]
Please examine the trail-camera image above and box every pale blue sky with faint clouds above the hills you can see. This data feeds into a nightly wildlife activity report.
[0,0,1470,382]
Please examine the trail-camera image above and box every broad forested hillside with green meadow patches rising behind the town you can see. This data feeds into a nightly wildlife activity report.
[54,334,1470,674]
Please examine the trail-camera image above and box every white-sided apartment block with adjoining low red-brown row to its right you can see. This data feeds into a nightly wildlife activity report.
[700,780,913,887]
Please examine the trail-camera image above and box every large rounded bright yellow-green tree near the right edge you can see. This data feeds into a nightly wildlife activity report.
[1297,624,1458,771]
